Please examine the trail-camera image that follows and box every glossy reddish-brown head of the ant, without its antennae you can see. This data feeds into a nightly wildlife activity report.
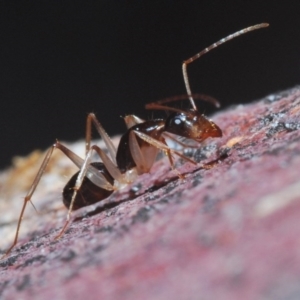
[165,110,222,142]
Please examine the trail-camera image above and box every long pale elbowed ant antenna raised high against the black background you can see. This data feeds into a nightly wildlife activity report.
[182,23,269,110]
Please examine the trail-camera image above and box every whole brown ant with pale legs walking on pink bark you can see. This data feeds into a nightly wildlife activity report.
[2,23,269,258]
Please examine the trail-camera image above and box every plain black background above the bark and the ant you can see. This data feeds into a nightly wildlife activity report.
[0,0,300,168]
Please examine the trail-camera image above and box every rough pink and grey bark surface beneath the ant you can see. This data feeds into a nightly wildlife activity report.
[0,88,300,300]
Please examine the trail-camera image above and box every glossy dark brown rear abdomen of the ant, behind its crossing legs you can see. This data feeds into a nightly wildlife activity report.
[62,162,114,210]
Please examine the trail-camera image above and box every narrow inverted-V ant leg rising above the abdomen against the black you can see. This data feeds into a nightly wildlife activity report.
[85,113,117,164]
